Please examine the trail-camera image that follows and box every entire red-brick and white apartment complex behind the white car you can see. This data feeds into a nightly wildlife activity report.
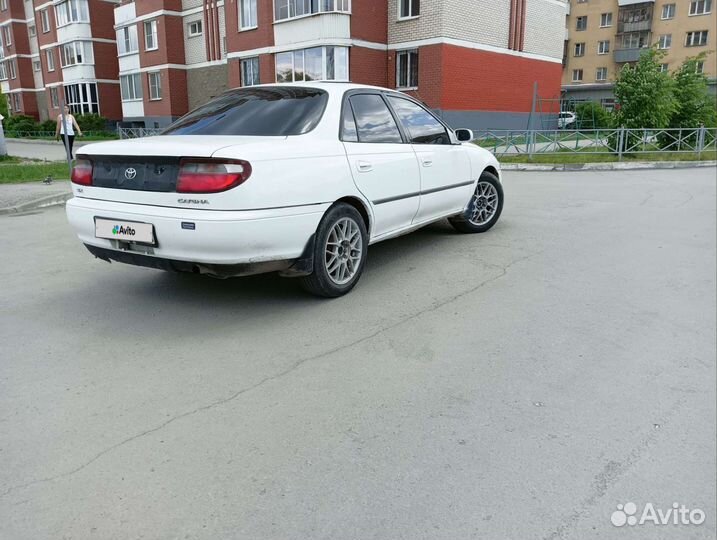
[0,0,567,128]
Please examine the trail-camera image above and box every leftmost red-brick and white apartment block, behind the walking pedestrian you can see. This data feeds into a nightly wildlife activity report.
[0,0,122,120]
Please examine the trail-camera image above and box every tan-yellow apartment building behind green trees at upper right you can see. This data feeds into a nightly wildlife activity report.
[563,0,717,107]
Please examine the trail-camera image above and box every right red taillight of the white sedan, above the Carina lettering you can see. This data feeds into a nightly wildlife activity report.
[177,159,251,193]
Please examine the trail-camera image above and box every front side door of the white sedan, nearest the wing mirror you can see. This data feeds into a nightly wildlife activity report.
[387,94,473,223]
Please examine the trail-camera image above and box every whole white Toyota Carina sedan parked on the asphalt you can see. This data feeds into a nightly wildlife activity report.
[67,83,503,297]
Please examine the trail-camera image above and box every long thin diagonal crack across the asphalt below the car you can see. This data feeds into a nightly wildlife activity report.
[0,250,544,498]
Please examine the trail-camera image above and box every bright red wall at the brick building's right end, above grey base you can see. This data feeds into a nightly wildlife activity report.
[440,45,562,112]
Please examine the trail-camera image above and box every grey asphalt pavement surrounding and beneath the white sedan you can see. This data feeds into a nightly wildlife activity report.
[0,169,717,540]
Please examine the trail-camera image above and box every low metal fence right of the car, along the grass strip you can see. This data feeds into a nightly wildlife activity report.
[474,127,717,159]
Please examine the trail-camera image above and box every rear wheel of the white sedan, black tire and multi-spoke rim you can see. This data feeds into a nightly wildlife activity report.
[301,203,368,298]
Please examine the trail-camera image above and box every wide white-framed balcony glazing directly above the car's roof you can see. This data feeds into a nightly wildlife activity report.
[274,47,349,82]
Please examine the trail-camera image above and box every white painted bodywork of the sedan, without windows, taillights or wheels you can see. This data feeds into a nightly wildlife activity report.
[67,82,500,277]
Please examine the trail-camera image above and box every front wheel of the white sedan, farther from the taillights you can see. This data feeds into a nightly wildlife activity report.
[448,171,503,233]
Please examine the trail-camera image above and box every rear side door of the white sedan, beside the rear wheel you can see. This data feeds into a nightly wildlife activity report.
[341,92,420,237]
